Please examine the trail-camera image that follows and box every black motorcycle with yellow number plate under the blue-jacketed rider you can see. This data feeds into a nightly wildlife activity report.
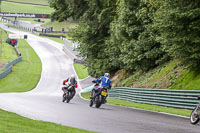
[89,86,108,108]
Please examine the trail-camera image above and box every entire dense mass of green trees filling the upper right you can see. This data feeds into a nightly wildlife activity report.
[50,0,200,88]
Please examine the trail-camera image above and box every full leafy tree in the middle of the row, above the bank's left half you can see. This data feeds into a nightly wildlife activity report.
[109,0,168,71]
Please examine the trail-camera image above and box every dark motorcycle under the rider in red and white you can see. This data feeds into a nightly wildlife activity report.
[63,84,75,103]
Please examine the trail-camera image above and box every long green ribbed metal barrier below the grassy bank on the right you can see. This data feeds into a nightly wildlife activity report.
[109,87,200,109]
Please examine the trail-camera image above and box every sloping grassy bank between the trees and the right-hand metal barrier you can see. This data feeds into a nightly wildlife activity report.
[112,60,200,90]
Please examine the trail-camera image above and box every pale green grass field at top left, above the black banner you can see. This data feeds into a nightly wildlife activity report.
[1,1,54,14]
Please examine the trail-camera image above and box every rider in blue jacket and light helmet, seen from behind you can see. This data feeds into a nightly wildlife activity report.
[90,73,112,102]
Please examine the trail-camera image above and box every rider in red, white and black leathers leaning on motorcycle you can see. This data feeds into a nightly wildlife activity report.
[62,75,78,99]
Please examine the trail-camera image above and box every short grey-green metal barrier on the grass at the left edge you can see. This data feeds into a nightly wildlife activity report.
[0,56,22,79]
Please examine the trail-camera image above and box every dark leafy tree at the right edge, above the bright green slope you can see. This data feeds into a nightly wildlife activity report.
[154,0,200,68]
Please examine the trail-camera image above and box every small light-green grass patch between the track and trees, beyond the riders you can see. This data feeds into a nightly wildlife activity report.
[73,64,88,79]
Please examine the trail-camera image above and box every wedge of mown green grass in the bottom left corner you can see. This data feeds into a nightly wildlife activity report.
[0,110,93,133]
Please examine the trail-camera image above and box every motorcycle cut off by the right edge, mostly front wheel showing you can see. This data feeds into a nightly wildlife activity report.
[190,96,200,124]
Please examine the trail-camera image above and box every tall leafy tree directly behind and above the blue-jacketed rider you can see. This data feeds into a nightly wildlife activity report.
[70,0,116,76]
